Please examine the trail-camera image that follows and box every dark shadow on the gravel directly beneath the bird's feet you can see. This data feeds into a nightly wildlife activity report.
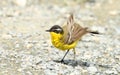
[53,59,90,67]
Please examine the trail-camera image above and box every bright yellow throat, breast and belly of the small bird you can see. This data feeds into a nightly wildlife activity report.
[50,32,78,50]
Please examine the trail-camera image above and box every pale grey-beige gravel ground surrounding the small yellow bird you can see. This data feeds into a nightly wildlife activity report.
[0,0,120,75]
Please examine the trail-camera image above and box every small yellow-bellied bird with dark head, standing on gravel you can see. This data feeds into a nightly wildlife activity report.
[46,14,99,62]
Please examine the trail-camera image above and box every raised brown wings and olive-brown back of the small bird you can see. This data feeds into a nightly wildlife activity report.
[62,14,87,44]
